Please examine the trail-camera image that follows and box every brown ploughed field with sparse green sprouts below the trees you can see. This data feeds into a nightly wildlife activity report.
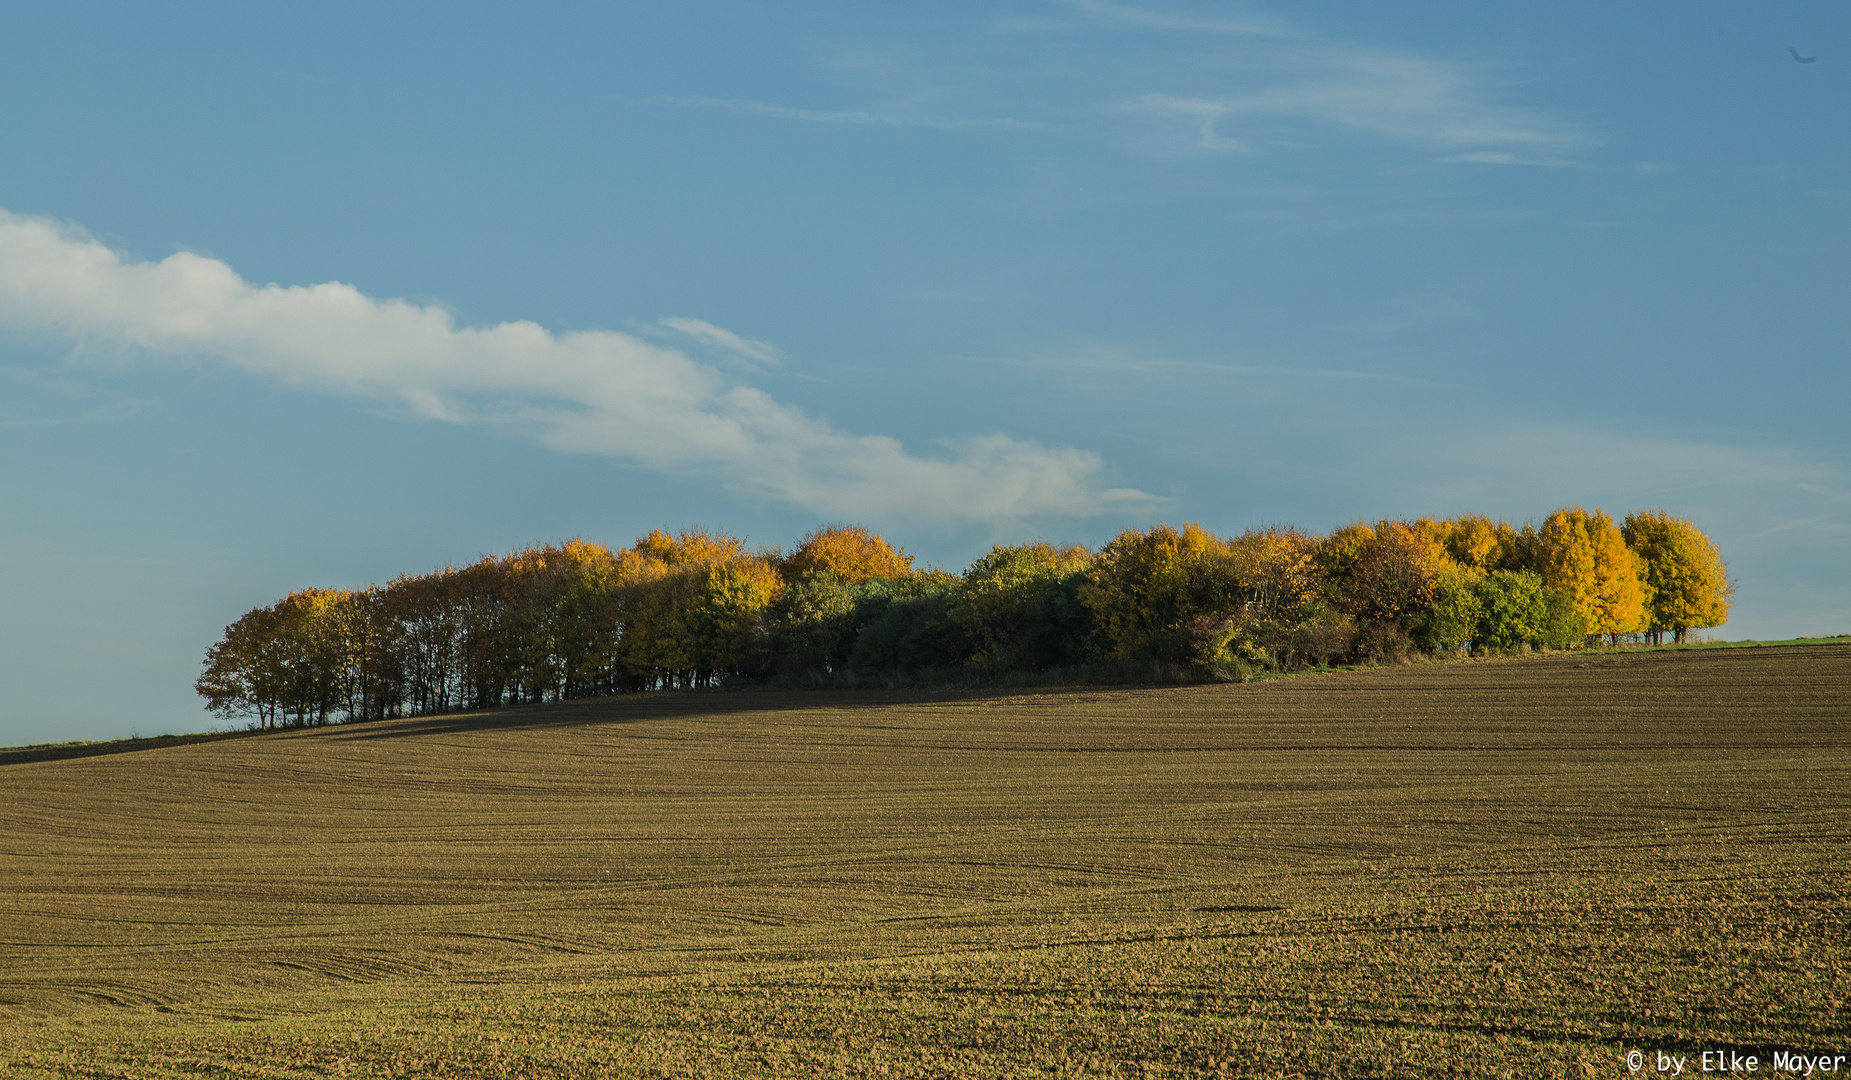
[0,643,1851,1078]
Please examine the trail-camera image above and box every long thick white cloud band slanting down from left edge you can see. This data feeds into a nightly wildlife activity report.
[0,211,1153,522]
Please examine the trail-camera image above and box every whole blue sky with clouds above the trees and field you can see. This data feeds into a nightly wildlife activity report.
[0,0,1851,743]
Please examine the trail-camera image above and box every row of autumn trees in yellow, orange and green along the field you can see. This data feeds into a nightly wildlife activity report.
[194,506,1734,728]
